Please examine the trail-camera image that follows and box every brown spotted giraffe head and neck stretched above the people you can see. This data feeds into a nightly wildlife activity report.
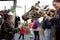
[22,5,54,21]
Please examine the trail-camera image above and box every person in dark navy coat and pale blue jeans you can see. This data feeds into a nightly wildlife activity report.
[42,16,51,40]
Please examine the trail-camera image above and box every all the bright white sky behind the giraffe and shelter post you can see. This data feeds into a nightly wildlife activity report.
[0,0,53,22]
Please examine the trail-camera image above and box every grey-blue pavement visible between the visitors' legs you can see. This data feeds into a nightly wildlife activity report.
[14,33,44,40]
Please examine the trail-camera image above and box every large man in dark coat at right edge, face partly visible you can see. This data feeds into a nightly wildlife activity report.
[53,0,60,40]
